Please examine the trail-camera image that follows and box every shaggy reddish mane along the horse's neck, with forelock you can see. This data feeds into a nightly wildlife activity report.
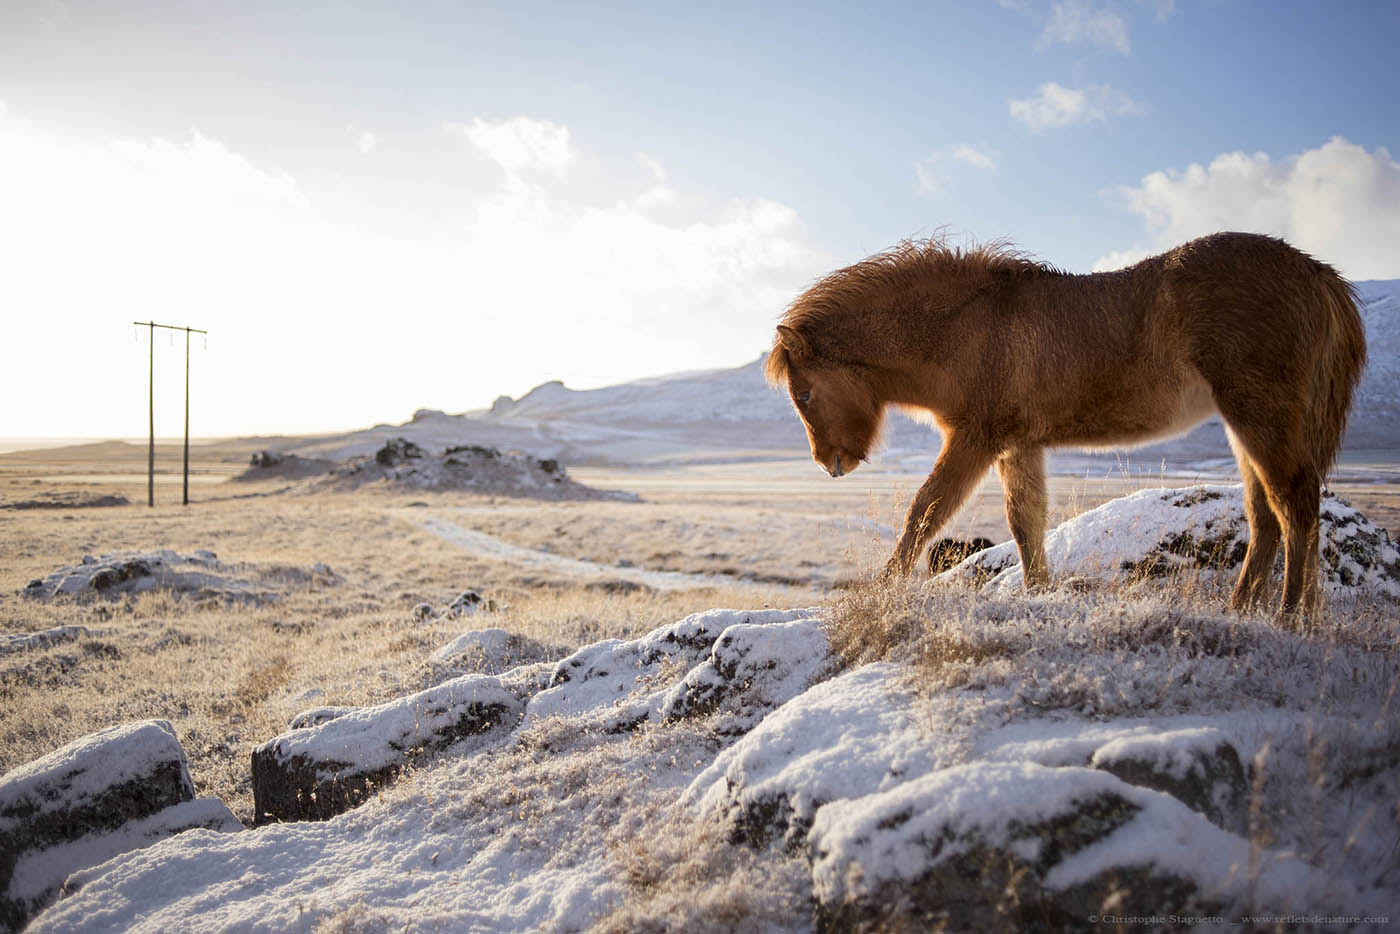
[763,237,1060,386]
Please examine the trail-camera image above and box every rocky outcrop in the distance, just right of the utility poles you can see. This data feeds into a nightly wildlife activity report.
[308,438,637,500]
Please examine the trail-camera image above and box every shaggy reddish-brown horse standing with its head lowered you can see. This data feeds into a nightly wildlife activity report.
[767,234,1366,612]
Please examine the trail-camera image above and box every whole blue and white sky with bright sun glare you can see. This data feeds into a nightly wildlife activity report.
[0,0,1400,437]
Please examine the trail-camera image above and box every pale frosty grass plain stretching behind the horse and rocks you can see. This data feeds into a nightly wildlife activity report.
[8,441,1400,818]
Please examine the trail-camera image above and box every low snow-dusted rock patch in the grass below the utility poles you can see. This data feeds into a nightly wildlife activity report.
[22,549,337,604]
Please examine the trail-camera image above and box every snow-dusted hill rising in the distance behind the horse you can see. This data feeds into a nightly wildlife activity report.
[290,280,1400,471]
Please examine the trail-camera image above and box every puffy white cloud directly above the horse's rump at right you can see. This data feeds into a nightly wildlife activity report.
[1095,136,1400,279]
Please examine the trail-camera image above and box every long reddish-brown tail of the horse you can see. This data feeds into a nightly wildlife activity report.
[1309,266,1366,478]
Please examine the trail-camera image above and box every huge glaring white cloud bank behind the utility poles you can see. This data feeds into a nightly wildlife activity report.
[0,107,832,437]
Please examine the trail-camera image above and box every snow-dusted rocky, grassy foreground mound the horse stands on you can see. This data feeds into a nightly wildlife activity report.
[13,500,1400,931]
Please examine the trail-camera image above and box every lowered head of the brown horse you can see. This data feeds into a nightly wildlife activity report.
[767,325,883,476]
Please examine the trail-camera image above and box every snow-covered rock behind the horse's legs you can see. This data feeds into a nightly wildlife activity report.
[934,485,1400,598]
